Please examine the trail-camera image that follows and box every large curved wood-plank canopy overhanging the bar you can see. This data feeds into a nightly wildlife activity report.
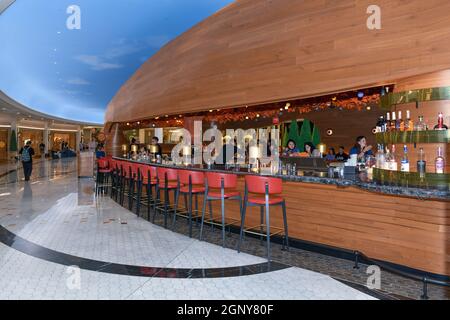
[105,0,450,122]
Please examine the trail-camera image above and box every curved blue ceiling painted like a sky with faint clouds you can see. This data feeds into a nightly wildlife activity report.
[0,0,232,123]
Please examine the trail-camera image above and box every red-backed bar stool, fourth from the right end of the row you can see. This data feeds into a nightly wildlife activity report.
[156,167,181,228]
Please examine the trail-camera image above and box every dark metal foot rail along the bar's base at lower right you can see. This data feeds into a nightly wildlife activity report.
[353,251,450,300]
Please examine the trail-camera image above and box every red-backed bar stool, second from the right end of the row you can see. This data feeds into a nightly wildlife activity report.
[200,172,242,247]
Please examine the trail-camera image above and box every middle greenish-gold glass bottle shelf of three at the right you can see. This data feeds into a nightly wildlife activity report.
[375,130,450,144]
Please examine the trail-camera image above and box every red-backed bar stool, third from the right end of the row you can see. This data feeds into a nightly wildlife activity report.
[172,170,206,238]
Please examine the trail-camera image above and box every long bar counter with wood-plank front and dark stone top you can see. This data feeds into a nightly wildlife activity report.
[115,158,450,276]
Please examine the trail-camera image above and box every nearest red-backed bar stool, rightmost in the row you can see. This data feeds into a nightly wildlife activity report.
[238,175,289,261]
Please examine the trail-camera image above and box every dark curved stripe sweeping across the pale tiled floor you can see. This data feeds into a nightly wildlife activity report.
[0,225,291,279]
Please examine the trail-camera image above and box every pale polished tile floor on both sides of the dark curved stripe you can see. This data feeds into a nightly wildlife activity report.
[0,160,374,300]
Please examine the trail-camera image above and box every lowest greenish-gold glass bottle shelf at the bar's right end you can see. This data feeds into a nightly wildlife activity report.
[373,168,450,191]
